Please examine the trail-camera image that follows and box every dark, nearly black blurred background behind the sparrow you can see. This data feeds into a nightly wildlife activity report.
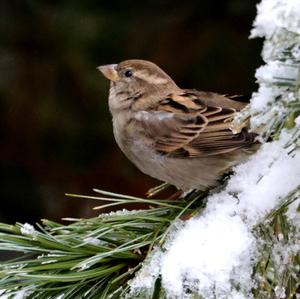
[0,0,262,223]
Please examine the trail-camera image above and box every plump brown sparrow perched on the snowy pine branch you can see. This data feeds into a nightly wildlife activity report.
[98,60,256,191]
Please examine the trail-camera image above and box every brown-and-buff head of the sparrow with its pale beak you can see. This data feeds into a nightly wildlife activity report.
[98,59,178,113]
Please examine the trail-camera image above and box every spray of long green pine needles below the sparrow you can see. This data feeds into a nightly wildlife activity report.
[0,190,203,298]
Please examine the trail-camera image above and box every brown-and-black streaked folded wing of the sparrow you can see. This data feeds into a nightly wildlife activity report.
[137,91,254,158]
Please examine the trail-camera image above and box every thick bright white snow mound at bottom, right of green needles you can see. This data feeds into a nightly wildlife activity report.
[161,214,255,298]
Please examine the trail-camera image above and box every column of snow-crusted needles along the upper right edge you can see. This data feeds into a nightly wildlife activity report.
[246,0,300,131]
